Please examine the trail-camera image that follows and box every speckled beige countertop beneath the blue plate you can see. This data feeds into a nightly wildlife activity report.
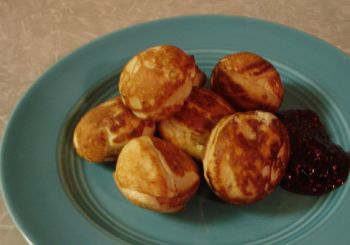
[0,0,350,245]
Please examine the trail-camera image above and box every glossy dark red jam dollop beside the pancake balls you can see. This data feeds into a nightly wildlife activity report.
[277,110,350,195]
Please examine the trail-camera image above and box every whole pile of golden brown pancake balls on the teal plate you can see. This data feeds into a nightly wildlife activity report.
[73,45,290,213]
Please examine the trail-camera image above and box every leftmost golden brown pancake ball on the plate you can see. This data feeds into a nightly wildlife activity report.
[73,96,155,162]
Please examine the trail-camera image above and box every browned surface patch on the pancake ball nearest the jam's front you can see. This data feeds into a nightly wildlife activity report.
[207,112,289,203]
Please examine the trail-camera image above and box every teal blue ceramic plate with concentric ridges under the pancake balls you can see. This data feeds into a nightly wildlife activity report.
[1,16,350,245]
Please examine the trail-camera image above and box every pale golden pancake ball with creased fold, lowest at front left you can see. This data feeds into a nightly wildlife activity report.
[113,136,200,213]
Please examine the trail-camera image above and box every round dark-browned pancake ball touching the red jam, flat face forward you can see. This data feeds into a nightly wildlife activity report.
[203,111,289,204]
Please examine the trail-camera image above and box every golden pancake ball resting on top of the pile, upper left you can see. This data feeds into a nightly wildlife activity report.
[119,45,196,120]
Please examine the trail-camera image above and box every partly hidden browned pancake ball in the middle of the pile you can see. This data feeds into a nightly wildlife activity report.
[158,87,235,160]
